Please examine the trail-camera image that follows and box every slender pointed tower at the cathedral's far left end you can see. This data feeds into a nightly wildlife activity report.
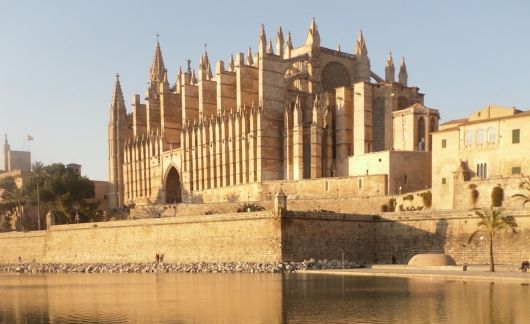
[108,74,128,208]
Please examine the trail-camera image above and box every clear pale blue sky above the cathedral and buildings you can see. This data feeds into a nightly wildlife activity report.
[0,0,530,180]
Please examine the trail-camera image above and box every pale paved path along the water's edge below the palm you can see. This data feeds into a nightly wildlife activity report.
[297,266,530,284]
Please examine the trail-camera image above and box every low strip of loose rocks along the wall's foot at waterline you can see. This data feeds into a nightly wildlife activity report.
[0,259,361,274]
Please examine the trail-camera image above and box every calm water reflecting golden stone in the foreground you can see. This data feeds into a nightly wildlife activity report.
[0,274,530,323]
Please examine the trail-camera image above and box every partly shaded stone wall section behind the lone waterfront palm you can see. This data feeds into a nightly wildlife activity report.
[374,209,530,264]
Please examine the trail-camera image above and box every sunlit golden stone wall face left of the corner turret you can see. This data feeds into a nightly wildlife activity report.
[0,212,280,263]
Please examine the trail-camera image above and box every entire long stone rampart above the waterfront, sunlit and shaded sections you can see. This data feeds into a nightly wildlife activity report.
[0,208,530,264]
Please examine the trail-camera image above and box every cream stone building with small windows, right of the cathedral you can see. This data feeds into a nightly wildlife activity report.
[432,105,530,209]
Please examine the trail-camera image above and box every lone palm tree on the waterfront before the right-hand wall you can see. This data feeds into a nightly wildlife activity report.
[468,207,517,272]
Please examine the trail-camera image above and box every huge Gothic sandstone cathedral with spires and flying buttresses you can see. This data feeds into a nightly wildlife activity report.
[108,19,439,207]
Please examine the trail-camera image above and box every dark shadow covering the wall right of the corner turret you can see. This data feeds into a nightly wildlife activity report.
[281,211,448,264]
